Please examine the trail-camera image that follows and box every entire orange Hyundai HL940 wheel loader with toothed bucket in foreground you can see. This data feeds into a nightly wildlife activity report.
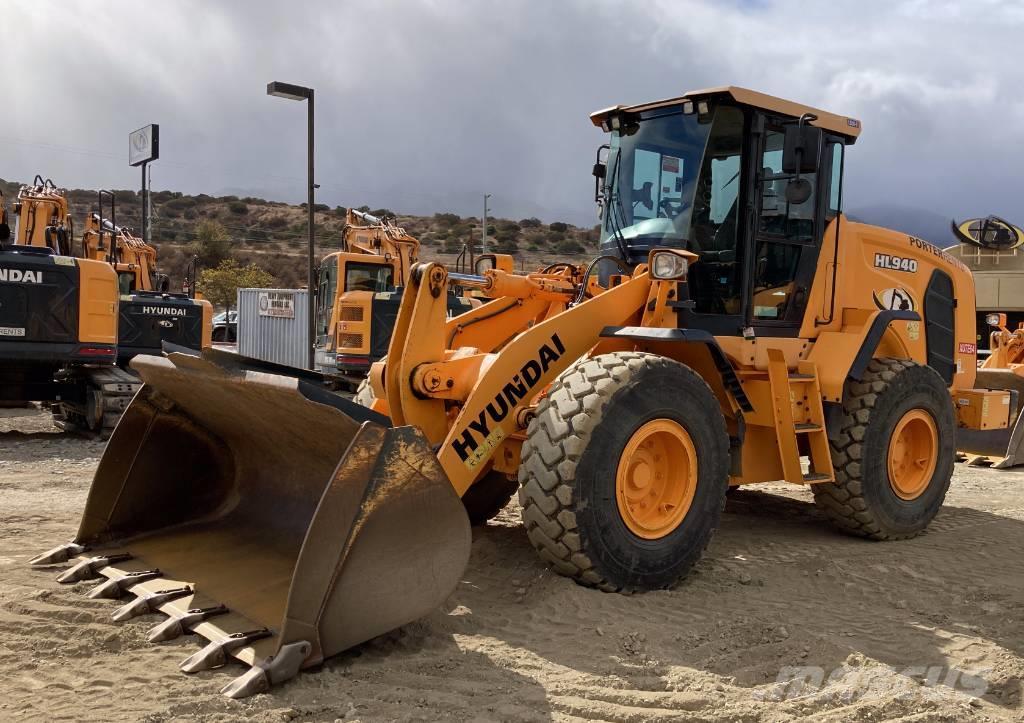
[33,87,1012,696]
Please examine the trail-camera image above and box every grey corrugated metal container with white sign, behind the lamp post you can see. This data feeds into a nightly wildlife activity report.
[238,289,309,369]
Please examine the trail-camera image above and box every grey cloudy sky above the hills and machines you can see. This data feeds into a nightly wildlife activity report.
[0,0,1024,222]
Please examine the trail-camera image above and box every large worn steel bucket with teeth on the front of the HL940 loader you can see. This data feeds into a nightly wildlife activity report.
[33,353,470,697]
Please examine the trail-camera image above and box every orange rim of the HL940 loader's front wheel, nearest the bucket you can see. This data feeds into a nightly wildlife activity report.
[615,419,697,540]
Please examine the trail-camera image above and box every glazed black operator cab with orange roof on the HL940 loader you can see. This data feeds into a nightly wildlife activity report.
[591,87,860,336]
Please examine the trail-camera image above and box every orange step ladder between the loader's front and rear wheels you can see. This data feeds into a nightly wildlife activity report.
[768,349,835,484]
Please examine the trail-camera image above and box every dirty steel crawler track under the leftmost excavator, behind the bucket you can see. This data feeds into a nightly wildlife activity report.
[52,367,142,439]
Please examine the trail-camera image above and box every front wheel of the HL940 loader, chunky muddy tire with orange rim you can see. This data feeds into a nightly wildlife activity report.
[519,352,729,592]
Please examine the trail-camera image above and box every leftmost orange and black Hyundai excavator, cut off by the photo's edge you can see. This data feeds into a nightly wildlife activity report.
[0,176,120,433]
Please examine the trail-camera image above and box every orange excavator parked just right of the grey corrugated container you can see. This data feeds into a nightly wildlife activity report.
[315,209,471,389]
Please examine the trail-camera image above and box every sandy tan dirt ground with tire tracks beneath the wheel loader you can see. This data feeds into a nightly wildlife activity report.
[0,411,1024,722]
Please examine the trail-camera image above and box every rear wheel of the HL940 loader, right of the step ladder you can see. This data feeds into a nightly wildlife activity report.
[811,358,956,540]
